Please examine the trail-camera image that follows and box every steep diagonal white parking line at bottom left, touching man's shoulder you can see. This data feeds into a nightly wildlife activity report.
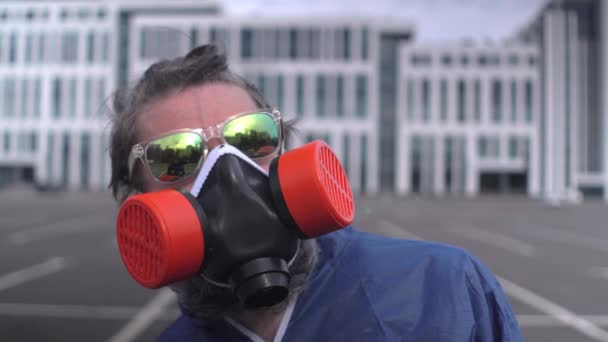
[108,288,175,342]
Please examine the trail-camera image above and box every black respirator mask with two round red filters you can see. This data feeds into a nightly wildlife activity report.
[116,141,354,309]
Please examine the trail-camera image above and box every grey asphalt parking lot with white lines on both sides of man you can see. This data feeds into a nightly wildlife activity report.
[0,188,608,342]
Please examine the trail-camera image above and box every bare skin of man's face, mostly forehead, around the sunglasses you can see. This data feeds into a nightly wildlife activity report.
[136,83,272,191]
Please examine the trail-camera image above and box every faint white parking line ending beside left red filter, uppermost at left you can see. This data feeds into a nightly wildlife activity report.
[7,214,107,245]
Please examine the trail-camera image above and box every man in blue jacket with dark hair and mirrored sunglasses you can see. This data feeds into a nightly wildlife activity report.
[111,45,522,341]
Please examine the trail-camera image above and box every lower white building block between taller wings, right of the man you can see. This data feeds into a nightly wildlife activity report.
[395,43,540,195]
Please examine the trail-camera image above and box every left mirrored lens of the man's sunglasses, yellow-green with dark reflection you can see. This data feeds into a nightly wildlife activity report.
[146,132,204,182]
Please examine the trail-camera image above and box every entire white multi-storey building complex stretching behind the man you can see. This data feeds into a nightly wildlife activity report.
[0,0,608,201]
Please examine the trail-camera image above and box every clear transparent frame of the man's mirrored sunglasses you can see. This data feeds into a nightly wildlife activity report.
[127,108,283,184]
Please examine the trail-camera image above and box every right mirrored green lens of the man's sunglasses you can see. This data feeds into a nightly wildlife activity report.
[224,113,279,158]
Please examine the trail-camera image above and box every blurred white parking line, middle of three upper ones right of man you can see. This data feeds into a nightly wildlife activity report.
[447,226,536,257]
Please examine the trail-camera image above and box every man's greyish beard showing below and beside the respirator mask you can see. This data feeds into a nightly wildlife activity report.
[170,239,317,320]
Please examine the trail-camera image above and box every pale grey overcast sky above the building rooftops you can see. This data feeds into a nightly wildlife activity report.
[219,0,545,42]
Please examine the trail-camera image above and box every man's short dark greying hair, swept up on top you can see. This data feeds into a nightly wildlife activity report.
[109,44,293,202]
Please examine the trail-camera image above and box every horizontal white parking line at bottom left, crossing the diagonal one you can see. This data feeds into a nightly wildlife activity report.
[0,303,179,320]
